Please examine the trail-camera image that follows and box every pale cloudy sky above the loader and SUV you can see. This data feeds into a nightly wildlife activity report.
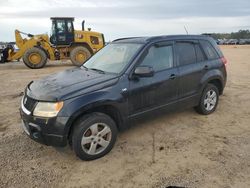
[0,0,250,41]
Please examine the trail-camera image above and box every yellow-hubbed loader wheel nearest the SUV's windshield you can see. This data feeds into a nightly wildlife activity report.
[70,46,91,67]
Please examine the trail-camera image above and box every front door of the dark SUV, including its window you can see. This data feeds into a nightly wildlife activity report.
[129,42,178,116]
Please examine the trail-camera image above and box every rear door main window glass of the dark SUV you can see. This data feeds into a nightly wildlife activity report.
[175,42,196,65]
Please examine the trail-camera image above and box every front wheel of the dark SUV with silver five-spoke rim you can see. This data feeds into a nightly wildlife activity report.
[72,113,117,161]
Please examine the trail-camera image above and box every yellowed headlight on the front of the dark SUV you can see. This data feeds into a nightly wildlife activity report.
[33,102,63,117]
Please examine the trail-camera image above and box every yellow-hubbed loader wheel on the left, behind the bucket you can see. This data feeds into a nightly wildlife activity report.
[23,47,48,69]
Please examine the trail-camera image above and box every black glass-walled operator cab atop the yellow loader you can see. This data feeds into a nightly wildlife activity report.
[50,17,74,46]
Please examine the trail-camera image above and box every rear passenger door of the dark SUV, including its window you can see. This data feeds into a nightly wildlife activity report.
[175,40,207,99]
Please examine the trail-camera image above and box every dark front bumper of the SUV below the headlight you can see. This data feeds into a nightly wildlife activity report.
[20,106,68,147]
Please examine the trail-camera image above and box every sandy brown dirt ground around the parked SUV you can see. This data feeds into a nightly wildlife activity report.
[0,46,250,188]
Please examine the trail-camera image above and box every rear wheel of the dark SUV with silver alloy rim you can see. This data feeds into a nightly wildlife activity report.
[195,84,219,115]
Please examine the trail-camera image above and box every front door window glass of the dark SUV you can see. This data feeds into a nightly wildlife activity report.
[141,45,174,72]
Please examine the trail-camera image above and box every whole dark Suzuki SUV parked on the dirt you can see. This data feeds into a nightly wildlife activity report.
[20,35,227,160]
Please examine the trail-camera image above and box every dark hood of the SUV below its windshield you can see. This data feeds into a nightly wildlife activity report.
[26,68,118,101]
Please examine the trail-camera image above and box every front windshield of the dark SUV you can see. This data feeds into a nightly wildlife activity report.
[84,43,142,74]
